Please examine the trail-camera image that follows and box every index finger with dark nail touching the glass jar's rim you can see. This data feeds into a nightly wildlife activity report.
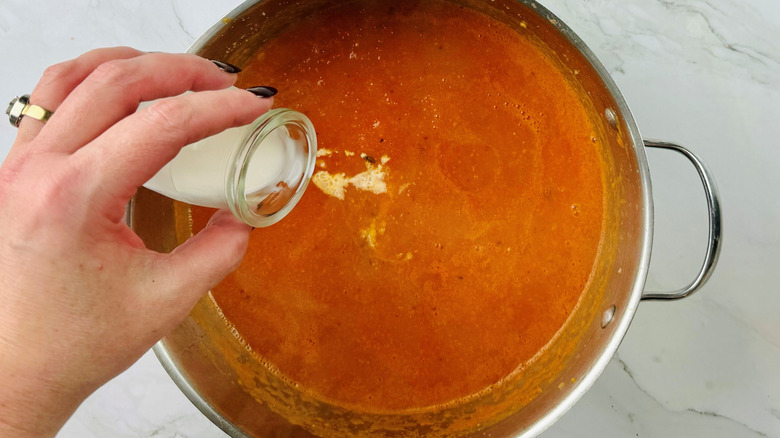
[71,88,273,218]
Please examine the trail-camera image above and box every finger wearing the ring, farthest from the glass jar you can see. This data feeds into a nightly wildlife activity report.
[17,47,144,141]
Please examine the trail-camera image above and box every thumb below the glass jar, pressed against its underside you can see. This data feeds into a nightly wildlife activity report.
[160,210,251,310]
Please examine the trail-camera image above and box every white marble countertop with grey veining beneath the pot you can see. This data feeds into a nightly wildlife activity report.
[0,0,780,438]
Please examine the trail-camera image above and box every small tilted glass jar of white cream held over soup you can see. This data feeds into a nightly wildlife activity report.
[144,108,317,227]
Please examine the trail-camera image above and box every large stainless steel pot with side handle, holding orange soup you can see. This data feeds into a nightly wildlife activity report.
[130,0,721,437]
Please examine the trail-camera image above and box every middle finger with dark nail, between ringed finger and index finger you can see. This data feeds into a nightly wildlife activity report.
[33,53,236,153]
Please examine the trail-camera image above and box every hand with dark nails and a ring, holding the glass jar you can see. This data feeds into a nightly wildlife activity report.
[0,48,272,437]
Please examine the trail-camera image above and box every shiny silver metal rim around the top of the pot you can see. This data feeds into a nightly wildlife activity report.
[153,0,653,438]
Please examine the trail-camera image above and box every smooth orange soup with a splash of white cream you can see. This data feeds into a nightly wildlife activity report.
[193,1,604,412]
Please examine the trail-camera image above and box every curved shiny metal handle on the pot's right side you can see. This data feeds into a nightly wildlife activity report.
[642,140,723,301]
